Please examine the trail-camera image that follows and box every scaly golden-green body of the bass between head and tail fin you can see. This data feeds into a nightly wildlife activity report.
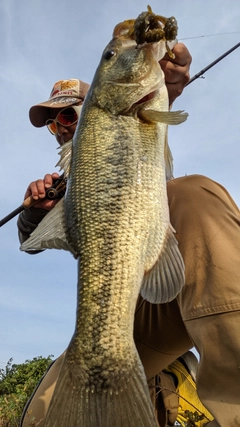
[54,107,171,424]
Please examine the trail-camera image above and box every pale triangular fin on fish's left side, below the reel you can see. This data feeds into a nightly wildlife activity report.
[20,198,77,258]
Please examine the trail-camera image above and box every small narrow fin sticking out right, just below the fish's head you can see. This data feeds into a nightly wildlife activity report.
[138,109,188,125]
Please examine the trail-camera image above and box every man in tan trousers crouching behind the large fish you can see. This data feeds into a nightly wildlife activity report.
[18,44,240,427]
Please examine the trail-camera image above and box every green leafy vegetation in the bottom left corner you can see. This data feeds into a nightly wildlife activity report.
[0,355,53,427]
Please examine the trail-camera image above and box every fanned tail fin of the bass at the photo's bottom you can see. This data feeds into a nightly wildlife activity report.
[45,354,158,427]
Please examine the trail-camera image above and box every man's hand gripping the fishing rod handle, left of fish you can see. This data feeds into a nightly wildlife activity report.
[24,172,59,211]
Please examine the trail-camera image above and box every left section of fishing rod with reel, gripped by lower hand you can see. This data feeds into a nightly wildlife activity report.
[0,175,67,227]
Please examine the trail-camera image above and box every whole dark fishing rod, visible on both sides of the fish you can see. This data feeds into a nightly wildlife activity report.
[0,43,240,227]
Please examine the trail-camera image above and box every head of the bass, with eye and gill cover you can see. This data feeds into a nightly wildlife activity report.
[88,32,170,115]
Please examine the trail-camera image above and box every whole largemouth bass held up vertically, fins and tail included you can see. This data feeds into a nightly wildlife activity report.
[22,7,186,427]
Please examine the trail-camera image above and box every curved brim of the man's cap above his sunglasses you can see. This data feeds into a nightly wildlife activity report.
[29,97,83,128]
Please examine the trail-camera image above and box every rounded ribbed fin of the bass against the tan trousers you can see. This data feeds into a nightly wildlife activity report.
[141,226,185,304]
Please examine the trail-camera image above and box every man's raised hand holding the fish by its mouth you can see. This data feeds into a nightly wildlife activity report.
[159,43,192,105]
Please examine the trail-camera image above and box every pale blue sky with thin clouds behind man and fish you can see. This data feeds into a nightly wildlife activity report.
[0,0,240,368]
